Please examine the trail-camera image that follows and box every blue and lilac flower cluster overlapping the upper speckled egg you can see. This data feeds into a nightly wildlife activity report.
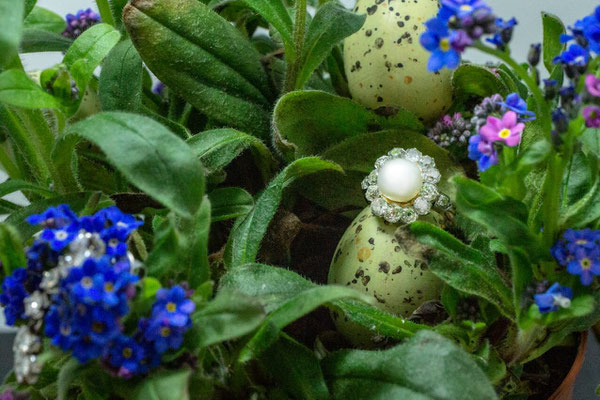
[420,0,517,72]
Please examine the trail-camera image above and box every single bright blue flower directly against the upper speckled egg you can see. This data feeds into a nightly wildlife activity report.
[420,18,460,72]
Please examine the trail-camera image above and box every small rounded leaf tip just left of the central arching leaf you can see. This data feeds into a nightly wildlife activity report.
[208,187,254,222]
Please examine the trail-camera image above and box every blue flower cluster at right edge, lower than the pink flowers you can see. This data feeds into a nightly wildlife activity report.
[552,229,600,286]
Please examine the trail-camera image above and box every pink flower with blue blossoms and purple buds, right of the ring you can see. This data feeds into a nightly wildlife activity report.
[469,93,535,171]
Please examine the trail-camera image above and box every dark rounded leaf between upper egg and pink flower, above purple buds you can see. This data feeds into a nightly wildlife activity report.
[452,64,509,99]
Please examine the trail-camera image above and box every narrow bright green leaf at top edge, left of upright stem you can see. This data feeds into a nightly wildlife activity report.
[244,0,296,61]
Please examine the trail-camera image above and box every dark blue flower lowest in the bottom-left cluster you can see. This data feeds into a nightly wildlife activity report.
[104,335,147,379]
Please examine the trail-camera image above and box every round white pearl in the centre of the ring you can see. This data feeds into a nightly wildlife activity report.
[377,158,423,203]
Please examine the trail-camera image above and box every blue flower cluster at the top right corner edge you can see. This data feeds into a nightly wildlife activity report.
[554,6,600,79]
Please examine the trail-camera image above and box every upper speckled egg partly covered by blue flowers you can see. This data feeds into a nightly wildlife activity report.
[344,0,452,121]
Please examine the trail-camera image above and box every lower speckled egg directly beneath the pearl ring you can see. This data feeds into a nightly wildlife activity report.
[328,207,442,346]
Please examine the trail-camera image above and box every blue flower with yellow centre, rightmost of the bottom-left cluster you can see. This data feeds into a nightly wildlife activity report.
[152,286,196,328]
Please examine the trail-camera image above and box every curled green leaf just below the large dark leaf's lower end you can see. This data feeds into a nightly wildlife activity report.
[187,129,275,178]
